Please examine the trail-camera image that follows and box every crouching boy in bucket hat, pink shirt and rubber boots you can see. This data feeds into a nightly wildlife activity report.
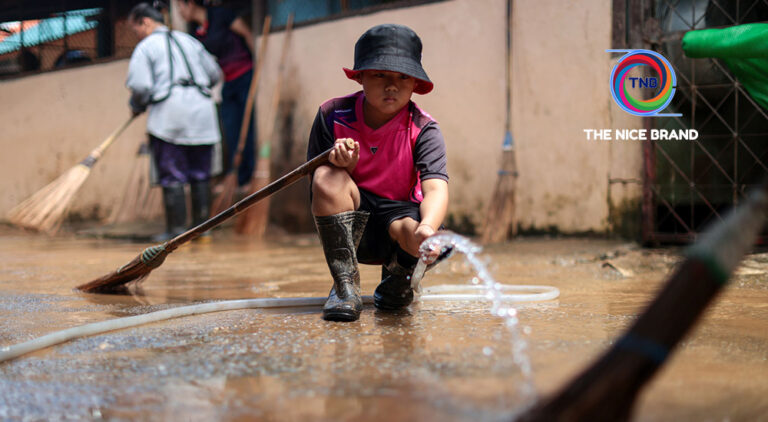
[307,24,448,321]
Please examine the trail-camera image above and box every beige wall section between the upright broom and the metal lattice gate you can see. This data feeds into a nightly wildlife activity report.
[513,0,642,232]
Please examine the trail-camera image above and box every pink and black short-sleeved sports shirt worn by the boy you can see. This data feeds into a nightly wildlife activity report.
[307,91,448,203]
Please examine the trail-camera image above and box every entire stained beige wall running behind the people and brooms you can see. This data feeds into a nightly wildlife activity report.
[0,0,642,237]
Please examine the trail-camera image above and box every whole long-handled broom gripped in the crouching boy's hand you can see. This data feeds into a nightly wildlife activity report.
[77,139,355,293]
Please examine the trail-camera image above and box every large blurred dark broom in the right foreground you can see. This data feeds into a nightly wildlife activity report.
[518,184,768,421]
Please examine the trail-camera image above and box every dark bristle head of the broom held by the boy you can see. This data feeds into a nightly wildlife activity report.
[75,244,169,293]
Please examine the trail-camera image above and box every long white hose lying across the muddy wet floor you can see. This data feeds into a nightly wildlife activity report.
[0,285,559,362]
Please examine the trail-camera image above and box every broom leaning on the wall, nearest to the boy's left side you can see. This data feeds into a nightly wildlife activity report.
[235,13,293,239]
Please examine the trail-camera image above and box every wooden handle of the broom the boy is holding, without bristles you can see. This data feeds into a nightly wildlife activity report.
[165,139,355,252]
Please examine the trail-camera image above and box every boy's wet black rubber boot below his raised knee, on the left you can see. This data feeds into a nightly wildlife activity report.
[315,211,368,321]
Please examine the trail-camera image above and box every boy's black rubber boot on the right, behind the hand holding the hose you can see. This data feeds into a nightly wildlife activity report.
[373,246,453,311]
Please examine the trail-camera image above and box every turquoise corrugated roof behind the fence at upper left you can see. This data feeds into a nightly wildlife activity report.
[0,8,102,54]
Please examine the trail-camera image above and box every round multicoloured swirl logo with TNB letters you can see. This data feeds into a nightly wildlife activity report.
[606,50,682,117]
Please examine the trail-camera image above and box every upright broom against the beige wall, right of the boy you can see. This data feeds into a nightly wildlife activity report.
[480,0,517,244]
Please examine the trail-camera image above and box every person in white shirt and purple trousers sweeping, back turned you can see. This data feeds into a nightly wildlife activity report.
[126,3,221,241]
